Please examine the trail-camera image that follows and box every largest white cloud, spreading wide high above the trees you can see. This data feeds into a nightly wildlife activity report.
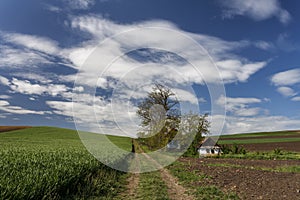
[66,15,267,86]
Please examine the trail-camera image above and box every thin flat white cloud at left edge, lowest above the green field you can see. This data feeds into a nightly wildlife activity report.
[0,100,49,115]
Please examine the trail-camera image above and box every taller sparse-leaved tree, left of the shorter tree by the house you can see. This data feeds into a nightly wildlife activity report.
[137,84,180,149]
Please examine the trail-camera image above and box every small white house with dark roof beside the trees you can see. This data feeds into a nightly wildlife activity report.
[198,137,221,157]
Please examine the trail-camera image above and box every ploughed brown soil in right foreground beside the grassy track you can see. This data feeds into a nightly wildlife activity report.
[180,158,300,200]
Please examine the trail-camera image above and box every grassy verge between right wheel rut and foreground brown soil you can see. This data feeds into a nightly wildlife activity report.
[168,161,239,200]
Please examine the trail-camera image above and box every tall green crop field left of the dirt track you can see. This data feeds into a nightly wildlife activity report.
[0,127,131,199]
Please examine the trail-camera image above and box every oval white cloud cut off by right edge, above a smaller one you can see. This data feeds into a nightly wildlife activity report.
[271,69,300,86]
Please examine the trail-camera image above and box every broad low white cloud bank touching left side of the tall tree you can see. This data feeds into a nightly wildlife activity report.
[47,97,140,136]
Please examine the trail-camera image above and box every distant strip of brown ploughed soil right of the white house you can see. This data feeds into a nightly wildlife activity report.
[241,142,300,152]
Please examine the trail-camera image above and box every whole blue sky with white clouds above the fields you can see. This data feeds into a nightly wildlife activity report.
[0,0,300,135]
